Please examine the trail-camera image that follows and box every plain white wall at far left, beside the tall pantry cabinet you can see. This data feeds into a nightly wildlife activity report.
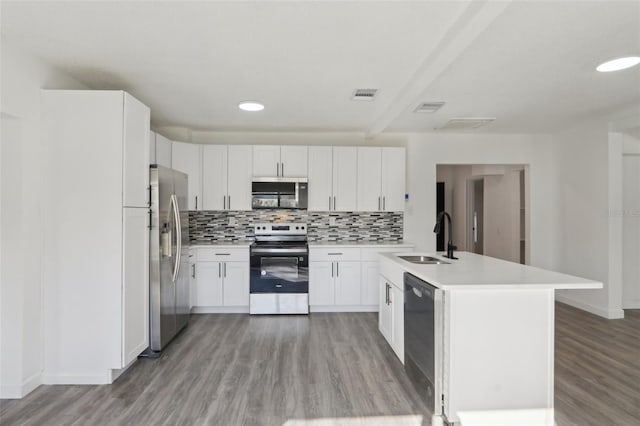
[0,38,86,398]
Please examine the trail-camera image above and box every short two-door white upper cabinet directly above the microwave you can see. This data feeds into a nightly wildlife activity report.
[253,145,307,177]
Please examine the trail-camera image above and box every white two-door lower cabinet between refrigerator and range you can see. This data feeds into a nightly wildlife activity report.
[192,247,249,313]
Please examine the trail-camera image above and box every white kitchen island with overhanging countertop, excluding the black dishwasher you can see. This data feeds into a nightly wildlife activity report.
[379,252,602,424]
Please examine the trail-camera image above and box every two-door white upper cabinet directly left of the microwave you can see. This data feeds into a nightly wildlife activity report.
[202,145,252,210]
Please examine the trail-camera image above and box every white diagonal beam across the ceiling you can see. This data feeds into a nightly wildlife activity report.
[366,0,512,138]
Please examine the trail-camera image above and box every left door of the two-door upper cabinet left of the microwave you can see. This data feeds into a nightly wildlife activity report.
[202,145,227,210]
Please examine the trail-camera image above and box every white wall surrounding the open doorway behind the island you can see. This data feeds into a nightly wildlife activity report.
[405,132,557,269]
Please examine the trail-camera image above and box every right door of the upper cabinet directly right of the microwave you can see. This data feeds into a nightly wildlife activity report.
[333,146,358,212]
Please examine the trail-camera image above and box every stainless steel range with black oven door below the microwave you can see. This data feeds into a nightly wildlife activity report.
[249,223,309,314]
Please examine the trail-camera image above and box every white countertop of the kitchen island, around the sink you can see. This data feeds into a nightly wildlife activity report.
[380,252,602,290]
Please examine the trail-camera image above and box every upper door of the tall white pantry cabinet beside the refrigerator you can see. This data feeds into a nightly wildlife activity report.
[122,93,150,207]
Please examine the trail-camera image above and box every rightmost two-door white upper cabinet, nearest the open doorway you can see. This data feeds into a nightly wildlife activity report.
[358,147,405,211]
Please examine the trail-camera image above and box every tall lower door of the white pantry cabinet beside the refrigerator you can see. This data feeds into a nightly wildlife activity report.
[122,208,149,367]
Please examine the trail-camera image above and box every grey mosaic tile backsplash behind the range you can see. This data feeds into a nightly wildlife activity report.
[189,210,403,244]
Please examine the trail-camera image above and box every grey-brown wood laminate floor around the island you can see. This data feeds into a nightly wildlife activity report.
[0,304,640,426]
